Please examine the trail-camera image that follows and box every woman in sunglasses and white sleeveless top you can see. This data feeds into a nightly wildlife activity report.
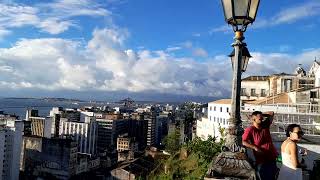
[278,124,304,180]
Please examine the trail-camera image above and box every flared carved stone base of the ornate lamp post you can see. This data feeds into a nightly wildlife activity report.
[204,151,257,180]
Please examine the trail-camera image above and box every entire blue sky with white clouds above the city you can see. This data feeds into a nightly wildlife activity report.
[0,0,320,101]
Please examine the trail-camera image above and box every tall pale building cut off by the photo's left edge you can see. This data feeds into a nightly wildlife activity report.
[0,120,23,180]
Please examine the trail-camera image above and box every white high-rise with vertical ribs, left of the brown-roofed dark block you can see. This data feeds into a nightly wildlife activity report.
[59,113,98,154]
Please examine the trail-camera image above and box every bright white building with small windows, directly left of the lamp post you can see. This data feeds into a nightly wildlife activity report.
[197,99,231,140]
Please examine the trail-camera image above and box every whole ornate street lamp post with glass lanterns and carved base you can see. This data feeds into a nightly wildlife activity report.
[206,0,260,179]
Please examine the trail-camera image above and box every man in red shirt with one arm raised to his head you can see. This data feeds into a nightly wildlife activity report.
[242,111,278,180]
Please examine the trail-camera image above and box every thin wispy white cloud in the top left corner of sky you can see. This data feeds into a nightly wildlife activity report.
[0,0,111,37]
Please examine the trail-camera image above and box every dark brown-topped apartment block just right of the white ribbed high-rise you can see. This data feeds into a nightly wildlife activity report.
[97,114,128,152]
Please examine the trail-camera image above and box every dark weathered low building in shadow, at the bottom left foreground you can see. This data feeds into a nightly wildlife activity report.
[23,137,77,179]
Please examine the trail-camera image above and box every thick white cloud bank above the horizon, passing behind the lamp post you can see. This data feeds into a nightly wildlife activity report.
[0,25,320,97]
